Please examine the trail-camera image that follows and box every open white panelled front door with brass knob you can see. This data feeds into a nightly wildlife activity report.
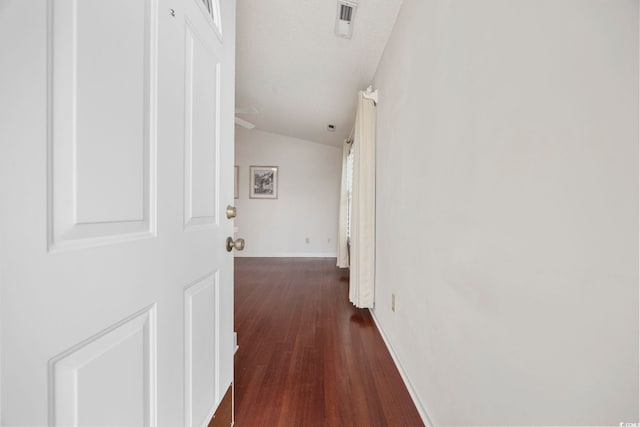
[0,0,235,426]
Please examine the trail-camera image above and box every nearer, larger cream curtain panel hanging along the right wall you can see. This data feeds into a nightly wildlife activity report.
[349,91,377,308]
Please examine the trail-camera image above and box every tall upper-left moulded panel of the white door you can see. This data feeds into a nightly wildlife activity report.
[47,0,157,249]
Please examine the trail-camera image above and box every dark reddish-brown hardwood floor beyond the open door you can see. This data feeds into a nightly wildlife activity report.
[235,258,424,427]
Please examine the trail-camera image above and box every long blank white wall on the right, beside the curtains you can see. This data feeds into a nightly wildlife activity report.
[374,0,639,425]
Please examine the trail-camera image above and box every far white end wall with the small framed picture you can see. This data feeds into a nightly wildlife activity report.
[235,126,342,257]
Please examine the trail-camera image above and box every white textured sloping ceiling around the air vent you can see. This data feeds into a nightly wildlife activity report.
[236,0,402,145]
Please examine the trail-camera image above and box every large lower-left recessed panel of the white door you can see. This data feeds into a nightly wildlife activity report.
[50,306,157,426]
